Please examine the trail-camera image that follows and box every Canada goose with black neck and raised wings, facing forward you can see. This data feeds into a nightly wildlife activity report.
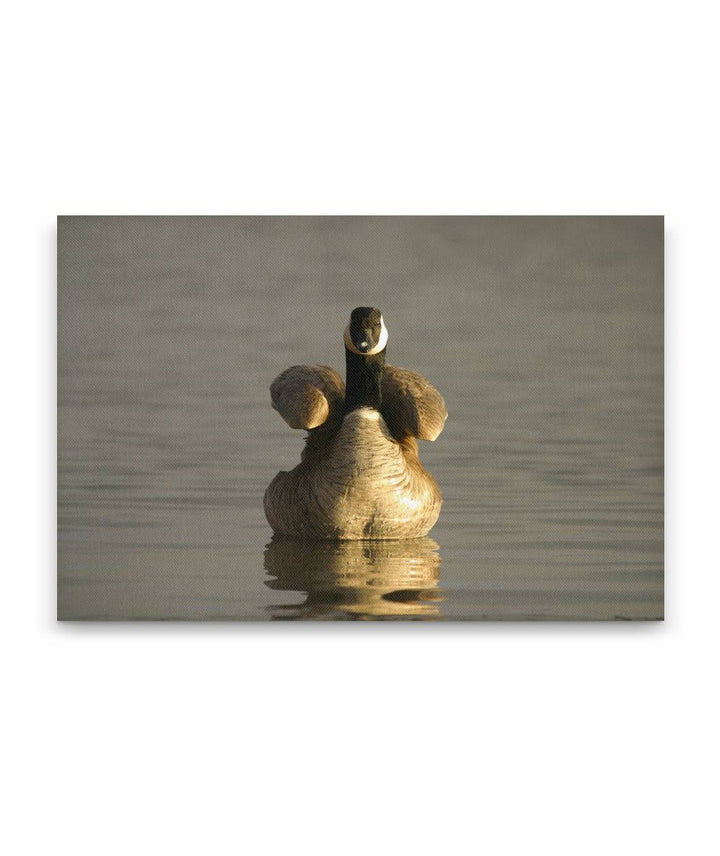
[264,306,447,539]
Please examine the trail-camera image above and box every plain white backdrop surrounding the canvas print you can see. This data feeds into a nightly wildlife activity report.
[0,0,720,856]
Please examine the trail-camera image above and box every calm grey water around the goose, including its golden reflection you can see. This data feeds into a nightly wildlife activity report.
[58,217,663,620]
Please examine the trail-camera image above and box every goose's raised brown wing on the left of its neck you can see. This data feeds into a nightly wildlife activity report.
[270,366,345,430]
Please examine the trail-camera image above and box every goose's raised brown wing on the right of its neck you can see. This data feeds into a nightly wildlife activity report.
[382,366,448,440]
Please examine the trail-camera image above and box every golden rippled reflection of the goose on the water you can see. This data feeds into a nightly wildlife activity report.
[265,535,442,620]
